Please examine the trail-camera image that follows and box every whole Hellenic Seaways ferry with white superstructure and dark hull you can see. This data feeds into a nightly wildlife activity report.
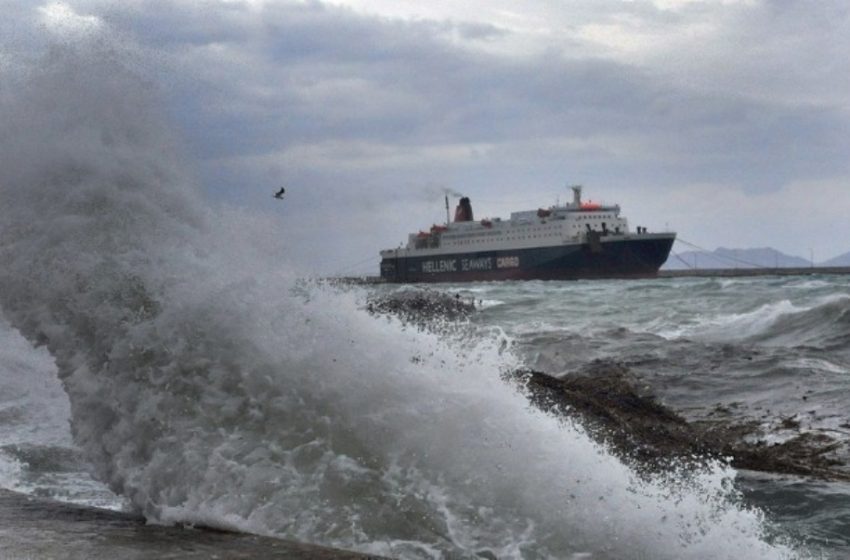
[381,186,676,282]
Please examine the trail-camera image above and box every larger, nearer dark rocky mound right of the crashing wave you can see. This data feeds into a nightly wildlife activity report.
[508,363,850,481]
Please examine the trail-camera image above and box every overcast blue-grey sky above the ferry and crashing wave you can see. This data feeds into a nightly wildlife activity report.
[0,0,850,274]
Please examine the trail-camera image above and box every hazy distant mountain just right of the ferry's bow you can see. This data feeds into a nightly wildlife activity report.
[662,247,812,270]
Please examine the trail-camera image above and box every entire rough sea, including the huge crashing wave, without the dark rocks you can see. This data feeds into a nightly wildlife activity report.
[0,34,850,560]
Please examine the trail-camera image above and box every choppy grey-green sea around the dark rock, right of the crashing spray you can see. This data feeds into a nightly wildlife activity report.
[445,275,850,558]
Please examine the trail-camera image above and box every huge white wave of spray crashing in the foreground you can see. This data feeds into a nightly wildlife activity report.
[0,23,793,558]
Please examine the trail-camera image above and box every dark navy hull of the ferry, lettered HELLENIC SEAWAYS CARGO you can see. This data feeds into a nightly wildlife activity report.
[381,234,675,283]
